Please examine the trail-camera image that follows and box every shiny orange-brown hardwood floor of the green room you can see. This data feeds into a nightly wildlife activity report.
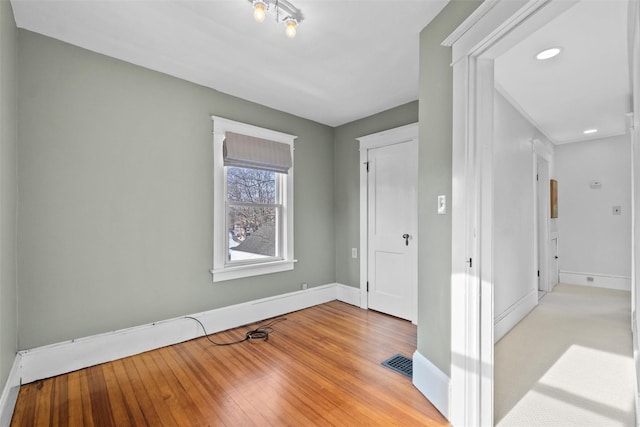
[11,301,448,426]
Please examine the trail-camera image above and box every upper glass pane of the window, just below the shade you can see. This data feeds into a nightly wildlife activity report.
[227,167,276,204]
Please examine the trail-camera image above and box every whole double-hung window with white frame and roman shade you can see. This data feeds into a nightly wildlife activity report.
[211,117,296,282]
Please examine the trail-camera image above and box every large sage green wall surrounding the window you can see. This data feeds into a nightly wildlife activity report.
[18,30,335,349]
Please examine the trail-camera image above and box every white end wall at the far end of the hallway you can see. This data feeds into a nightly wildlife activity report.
[556,136,631,290]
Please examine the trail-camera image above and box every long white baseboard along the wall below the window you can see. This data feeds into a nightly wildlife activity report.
[19,283,340,384]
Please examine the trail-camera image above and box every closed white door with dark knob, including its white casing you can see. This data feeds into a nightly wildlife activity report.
[358,124,418,323]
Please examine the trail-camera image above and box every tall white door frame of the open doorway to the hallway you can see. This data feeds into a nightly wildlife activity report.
[443,0,575,426]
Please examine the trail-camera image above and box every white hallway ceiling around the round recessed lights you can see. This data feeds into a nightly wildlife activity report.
[495,0,631,144]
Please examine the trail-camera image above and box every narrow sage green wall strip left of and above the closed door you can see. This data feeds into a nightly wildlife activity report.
[333,101,418,287]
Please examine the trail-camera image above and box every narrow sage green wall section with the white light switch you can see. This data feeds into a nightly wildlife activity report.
[418,0,482,375]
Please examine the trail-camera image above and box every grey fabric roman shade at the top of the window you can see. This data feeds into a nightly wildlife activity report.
[222,132,293,174]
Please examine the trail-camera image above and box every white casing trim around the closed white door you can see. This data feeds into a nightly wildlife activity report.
[356,123,418,323]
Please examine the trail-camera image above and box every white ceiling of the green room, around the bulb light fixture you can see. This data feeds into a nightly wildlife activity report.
[11,0,448,126]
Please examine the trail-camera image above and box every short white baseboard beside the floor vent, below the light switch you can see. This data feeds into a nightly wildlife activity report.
[413,350,451,419]
